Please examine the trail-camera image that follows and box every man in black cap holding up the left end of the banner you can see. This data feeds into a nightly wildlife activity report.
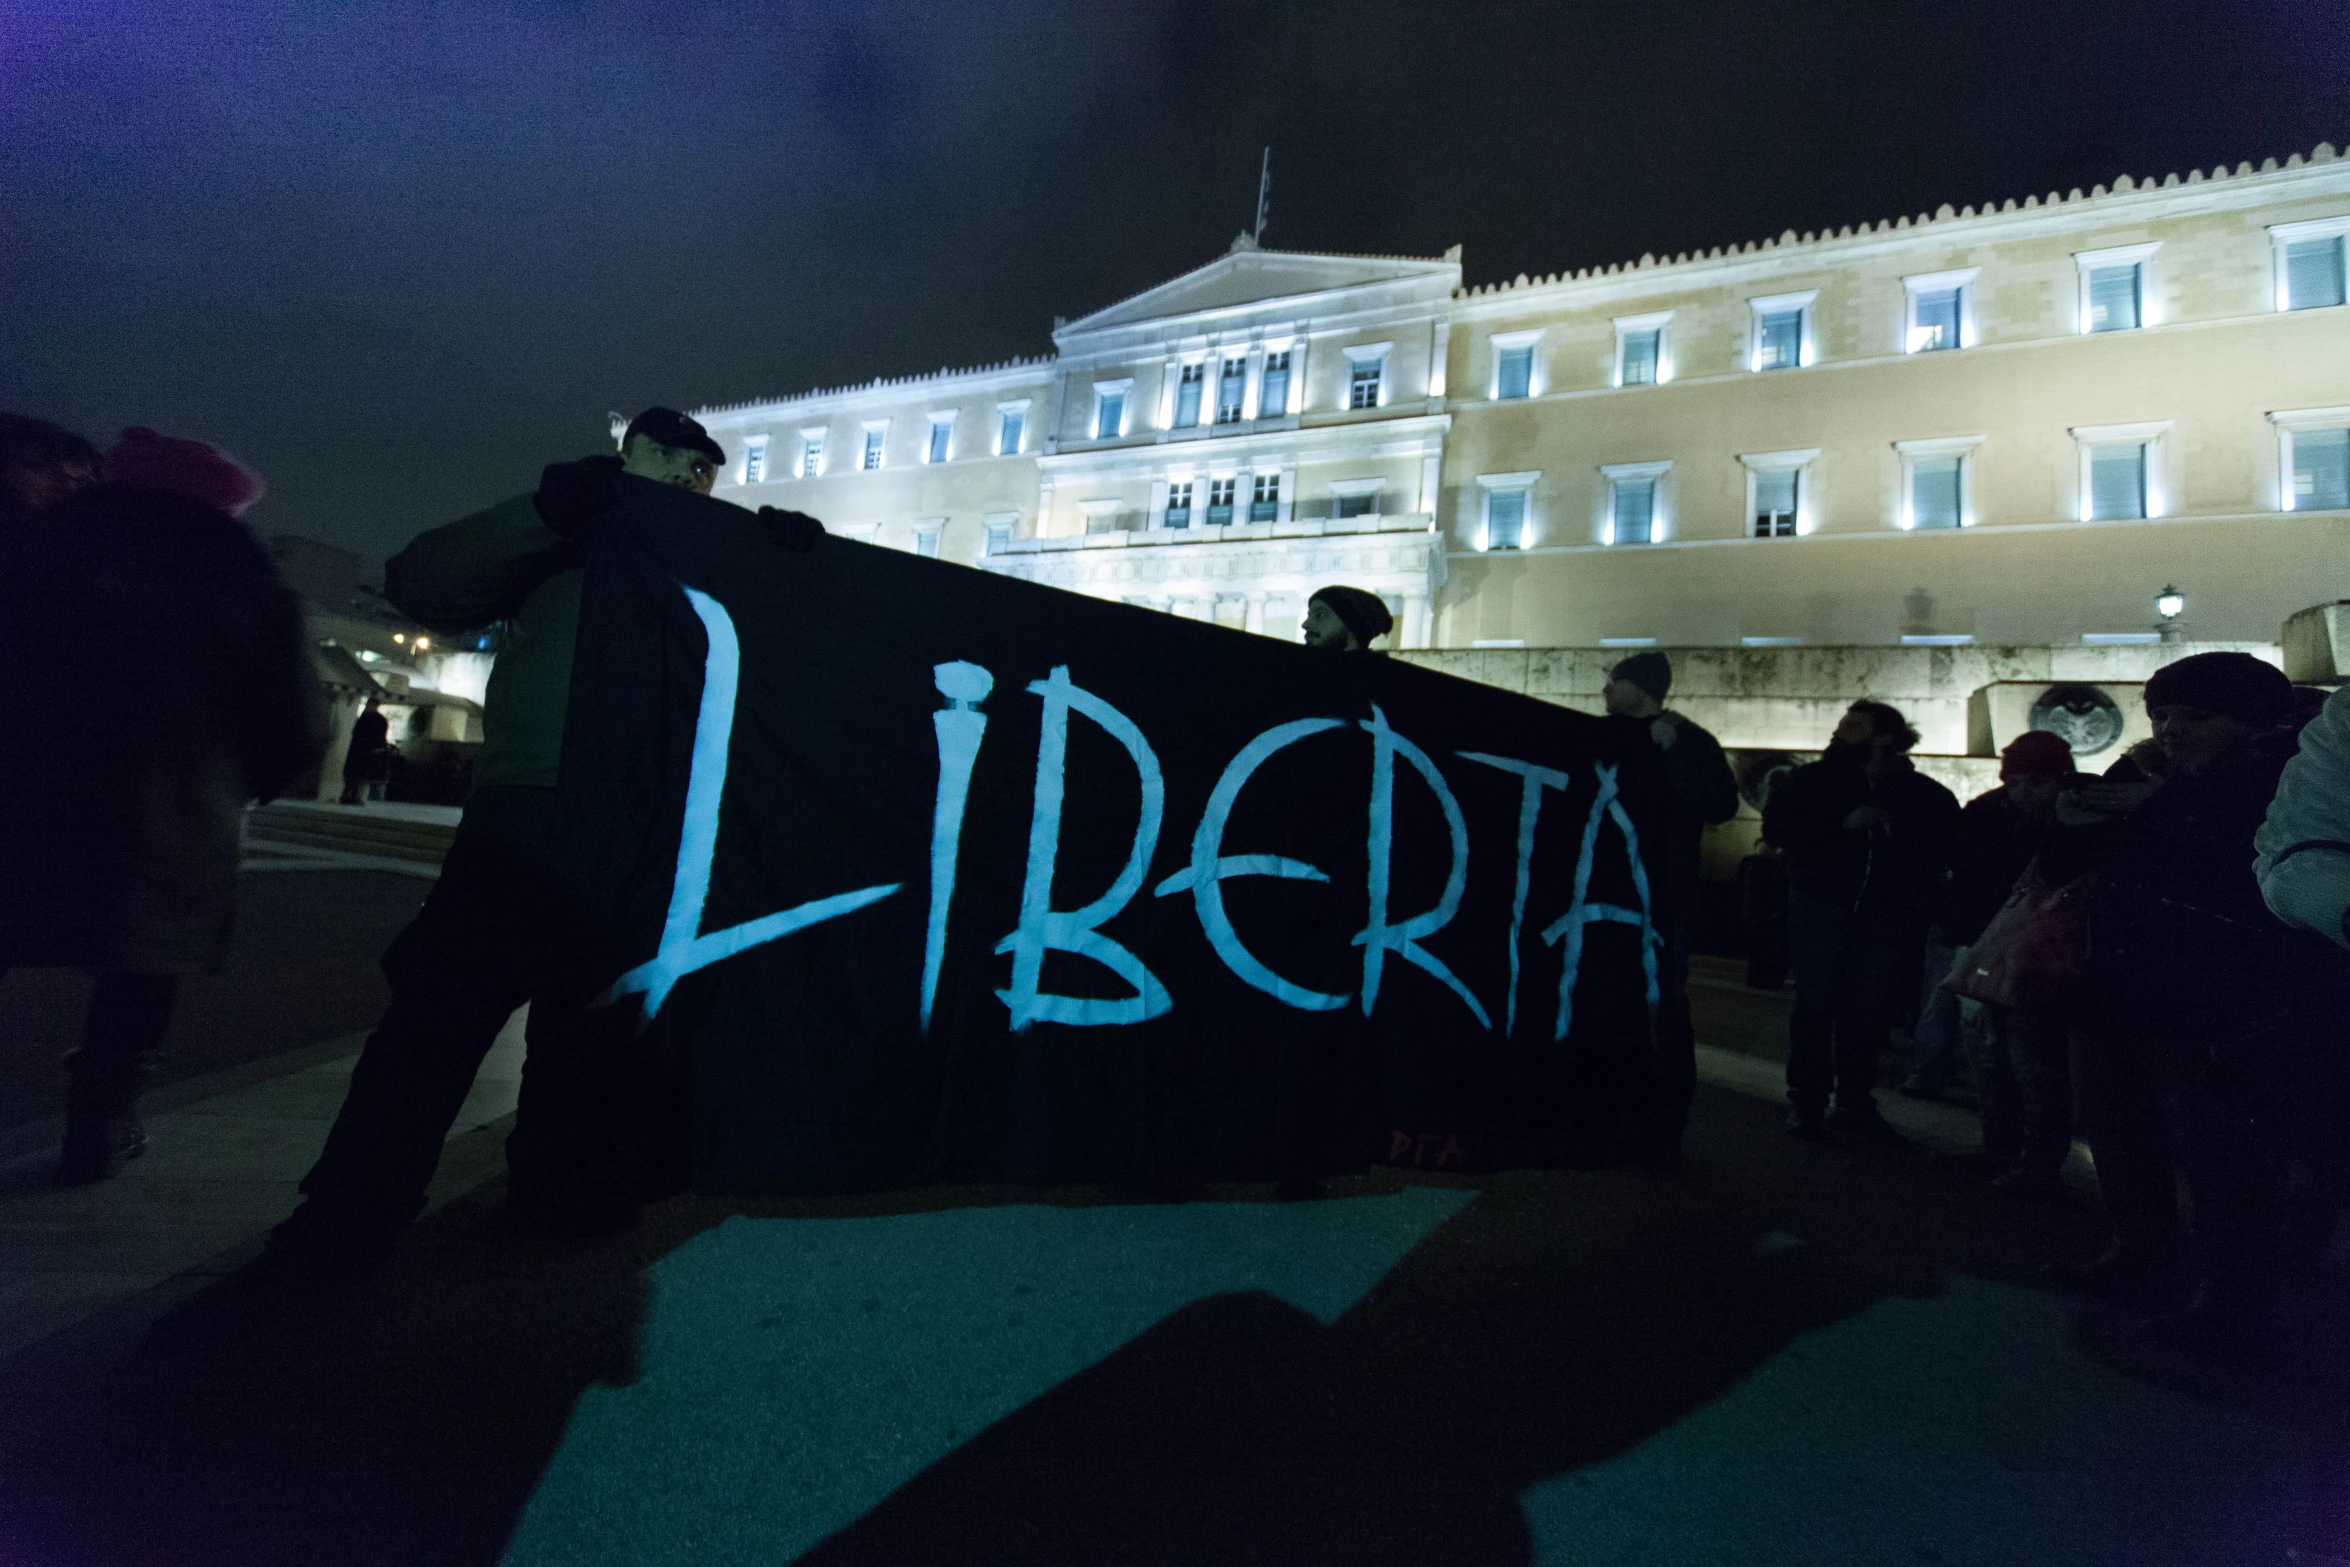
[273,409,823,1266]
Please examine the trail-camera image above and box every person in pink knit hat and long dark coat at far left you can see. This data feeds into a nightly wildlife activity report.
[0,430,324,1184]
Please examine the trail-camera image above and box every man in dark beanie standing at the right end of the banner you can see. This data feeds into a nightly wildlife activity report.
[1600,651,1739,1158]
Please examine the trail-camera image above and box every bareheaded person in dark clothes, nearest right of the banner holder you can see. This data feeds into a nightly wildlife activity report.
[1763,702,1958,1149]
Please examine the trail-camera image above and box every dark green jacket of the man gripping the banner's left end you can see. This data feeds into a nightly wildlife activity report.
[383,496,583,789]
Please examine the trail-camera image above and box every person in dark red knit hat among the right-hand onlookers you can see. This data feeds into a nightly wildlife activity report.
[1927,728,2077,1196]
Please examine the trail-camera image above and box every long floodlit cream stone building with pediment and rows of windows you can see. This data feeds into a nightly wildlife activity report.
[698,146,2350,780]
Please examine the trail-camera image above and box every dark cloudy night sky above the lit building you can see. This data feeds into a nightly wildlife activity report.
[0,0,2350,557]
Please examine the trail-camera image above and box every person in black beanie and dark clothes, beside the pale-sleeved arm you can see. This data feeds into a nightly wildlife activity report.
[2047,653,2296,1341]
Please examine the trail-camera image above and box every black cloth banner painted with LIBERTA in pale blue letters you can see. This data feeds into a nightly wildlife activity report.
[564,484,1669,1191]
